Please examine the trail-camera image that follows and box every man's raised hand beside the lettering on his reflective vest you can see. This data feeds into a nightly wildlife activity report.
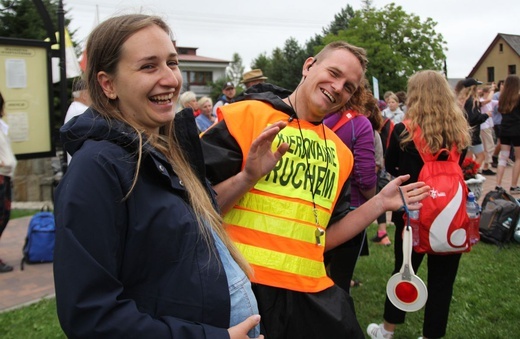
[243,121,289,184]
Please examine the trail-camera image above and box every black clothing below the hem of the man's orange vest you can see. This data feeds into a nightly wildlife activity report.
[253,284,365,339]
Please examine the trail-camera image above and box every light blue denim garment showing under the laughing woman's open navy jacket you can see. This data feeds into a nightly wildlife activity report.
[213,232,260,338]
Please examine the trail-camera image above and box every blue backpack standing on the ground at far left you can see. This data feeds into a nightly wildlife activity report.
[20,206,56,270]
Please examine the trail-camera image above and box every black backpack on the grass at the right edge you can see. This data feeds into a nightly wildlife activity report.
[479,188,520,247]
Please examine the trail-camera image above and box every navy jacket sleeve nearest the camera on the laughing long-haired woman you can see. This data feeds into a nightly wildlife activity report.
[54,142,229,338]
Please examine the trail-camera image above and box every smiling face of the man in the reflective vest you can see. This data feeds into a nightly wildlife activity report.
[300,49,363,121]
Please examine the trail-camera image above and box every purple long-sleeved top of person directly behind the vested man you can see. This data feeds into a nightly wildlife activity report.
[323,113,377,207]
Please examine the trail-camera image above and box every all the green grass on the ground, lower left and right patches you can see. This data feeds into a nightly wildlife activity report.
[0,225,520,339]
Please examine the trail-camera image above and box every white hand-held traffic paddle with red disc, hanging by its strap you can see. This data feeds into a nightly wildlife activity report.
[386,188,428,312]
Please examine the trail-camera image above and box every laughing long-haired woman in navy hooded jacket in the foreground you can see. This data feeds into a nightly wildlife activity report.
[54,14,280,339]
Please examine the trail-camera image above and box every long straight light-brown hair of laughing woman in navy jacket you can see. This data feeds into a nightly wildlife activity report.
[86,14,251,274]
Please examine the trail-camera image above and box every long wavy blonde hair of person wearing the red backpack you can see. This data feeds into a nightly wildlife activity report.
[401,71,471,153]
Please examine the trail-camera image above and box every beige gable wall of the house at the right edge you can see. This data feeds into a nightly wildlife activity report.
[472,38,520,83]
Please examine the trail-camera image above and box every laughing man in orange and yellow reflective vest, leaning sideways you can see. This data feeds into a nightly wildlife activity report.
[202,41,423,339]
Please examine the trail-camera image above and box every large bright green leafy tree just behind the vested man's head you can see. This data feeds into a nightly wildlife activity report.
[323,1,446,93]
